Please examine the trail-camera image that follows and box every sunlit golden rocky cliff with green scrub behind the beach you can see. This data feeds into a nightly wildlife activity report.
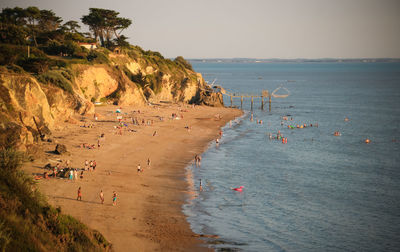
[0,46,223,150]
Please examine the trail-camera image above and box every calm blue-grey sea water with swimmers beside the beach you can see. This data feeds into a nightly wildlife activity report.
[184,63,400,251]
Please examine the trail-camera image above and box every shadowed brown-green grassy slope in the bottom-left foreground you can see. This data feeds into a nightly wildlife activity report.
[0,148,111,251]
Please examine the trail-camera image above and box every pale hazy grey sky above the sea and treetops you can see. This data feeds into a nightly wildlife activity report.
[0,0,400,58]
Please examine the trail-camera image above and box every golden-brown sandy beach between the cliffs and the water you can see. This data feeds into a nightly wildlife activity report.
[24,104,242,251]
